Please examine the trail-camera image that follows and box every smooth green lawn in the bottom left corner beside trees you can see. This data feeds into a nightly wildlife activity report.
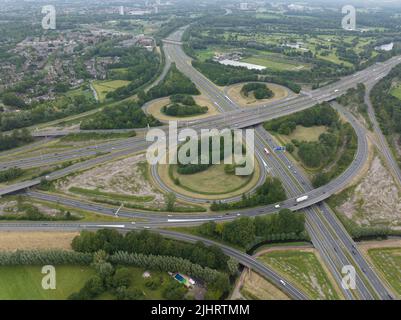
[0,266,94,300]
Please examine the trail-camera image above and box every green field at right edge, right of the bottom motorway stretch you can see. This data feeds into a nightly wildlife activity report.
[368,248,401,297]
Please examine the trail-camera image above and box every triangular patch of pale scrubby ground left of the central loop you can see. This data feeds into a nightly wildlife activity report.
[36,153,206,214]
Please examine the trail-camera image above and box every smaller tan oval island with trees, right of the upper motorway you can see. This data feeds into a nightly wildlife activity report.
[227,82,290,107]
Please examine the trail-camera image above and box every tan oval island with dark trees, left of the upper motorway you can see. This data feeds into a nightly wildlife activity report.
[146,94,218,121]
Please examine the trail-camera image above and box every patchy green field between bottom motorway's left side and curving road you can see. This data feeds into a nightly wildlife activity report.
[258,250,339,300]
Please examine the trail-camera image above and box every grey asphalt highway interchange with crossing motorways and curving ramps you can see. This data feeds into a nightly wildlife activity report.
[0,29,401,299]
